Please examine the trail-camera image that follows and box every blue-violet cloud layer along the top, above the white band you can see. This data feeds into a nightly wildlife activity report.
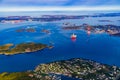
[0,0,120,6]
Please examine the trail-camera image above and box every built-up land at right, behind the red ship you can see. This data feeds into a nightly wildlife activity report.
[62,23,120,36]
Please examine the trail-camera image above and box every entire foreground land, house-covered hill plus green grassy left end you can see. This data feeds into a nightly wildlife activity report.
[0,58,120,80]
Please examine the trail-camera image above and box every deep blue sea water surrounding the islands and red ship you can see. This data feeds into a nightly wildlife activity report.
[0,17,120,72]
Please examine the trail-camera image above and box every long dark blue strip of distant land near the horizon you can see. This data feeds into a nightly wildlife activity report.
[0,13,120,22]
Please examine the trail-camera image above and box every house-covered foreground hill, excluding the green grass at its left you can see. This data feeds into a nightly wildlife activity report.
[33,58,120,80]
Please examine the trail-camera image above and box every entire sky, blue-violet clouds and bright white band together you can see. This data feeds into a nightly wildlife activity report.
[0,0,120,12]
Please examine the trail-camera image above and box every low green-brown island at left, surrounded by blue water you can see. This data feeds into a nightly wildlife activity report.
[0,42,52,55]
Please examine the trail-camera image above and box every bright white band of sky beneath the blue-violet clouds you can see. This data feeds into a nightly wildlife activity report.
[0,6,120,12]
